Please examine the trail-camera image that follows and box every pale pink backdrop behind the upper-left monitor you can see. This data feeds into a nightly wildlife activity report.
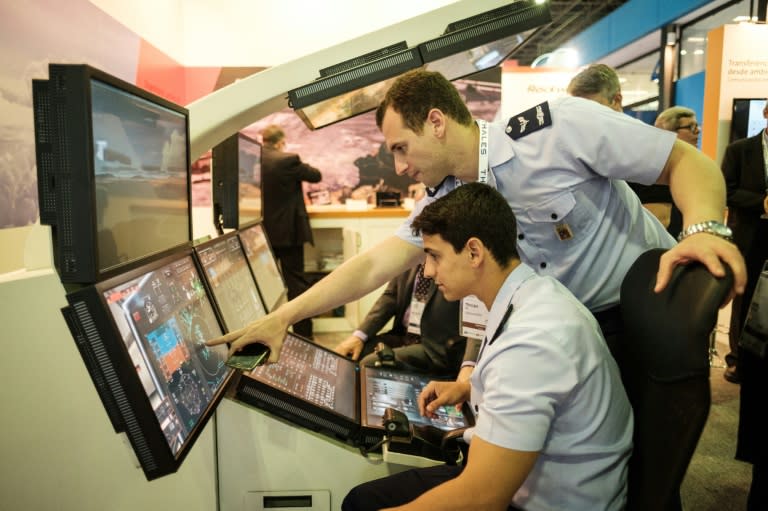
[0,0,140,228]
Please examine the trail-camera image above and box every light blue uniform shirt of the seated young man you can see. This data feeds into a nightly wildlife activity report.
[465,264,633,511]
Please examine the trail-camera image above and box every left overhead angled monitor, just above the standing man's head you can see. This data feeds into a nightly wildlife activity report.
[288,41,423,130]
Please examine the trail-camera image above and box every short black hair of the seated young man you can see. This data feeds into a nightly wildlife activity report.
[411,183,519,267]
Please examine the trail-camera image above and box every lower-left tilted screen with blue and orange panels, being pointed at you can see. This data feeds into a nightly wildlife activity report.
[103,255,232,454]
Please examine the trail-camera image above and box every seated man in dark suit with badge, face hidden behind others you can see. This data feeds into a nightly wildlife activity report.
[336,265,480,377]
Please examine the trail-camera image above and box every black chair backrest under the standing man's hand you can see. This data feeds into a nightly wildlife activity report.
[617,249,733,511]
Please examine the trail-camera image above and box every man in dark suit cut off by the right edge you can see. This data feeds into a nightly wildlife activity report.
[721,104,768,383]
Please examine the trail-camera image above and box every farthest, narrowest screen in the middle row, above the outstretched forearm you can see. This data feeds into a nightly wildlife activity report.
[239,223,287,312]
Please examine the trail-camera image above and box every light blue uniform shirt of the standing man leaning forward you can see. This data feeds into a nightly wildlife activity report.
[396,97,676,311]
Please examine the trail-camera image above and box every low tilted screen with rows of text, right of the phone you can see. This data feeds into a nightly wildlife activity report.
[248,334,358,421]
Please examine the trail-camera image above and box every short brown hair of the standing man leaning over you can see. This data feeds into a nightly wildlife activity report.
[376,69,473,135]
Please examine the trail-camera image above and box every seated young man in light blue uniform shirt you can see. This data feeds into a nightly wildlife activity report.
[342,183,633,511]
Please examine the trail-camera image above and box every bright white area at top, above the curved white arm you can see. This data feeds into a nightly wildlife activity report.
[90,0,462,67]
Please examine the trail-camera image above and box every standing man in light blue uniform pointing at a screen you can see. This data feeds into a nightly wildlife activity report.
[210,70,746,368]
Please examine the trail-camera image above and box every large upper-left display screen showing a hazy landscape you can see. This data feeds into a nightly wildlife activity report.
[91,79,190,271]
